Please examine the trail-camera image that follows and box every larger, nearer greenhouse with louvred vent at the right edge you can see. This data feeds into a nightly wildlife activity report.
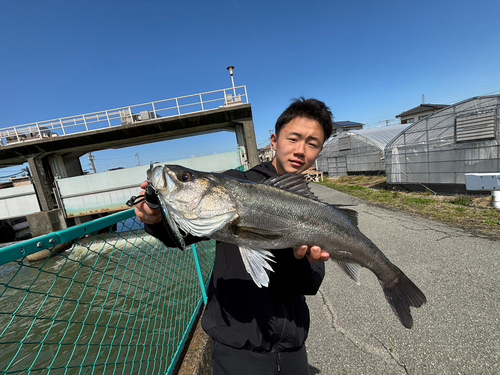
[385,95,500,192]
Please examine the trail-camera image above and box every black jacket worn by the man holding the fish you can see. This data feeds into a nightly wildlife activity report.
[146,162,325,352]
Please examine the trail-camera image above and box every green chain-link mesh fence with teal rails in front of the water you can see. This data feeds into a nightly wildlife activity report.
[0,210,215,374]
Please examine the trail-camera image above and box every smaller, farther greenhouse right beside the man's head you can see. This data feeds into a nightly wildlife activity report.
[317,125,409,177]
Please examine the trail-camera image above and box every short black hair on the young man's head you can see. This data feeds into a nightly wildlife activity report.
[274,96,333,141]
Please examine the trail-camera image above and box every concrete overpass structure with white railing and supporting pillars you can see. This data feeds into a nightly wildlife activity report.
[0,86,259,235]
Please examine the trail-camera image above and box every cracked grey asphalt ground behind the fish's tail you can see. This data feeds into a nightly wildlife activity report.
[306,184,500,375]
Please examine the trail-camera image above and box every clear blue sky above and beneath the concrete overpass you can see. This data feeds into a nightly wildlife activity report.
[0,0,500,176]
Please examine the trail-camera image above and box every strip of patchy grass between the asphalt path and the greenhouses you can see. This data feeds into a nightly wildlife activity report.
[320,176,500,239]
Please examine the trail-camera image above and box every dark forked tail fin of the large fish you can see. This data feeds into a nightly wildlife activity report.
[379,270,427,329]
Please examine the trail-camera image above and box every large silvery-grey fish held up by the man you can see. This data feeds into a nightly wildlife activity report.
[147,165,426,328]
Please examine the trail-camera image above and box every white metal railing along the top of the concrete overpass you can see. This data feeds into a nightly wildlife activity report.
[0,86,249,146]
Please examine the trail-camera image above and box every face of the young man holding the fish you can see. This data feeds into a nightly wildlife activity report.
[271,117,325,174]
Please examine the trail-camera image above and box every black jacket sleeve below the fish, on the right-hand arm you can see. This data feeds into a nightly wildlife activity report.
[270,249,325,295]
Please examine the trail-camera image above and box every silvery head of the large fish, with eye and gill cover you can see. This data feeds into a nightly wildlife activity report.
[147,165,236,236]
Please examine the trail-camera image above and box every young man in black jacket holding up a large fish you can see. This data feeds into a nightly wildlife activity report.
[136,98,332,375]
